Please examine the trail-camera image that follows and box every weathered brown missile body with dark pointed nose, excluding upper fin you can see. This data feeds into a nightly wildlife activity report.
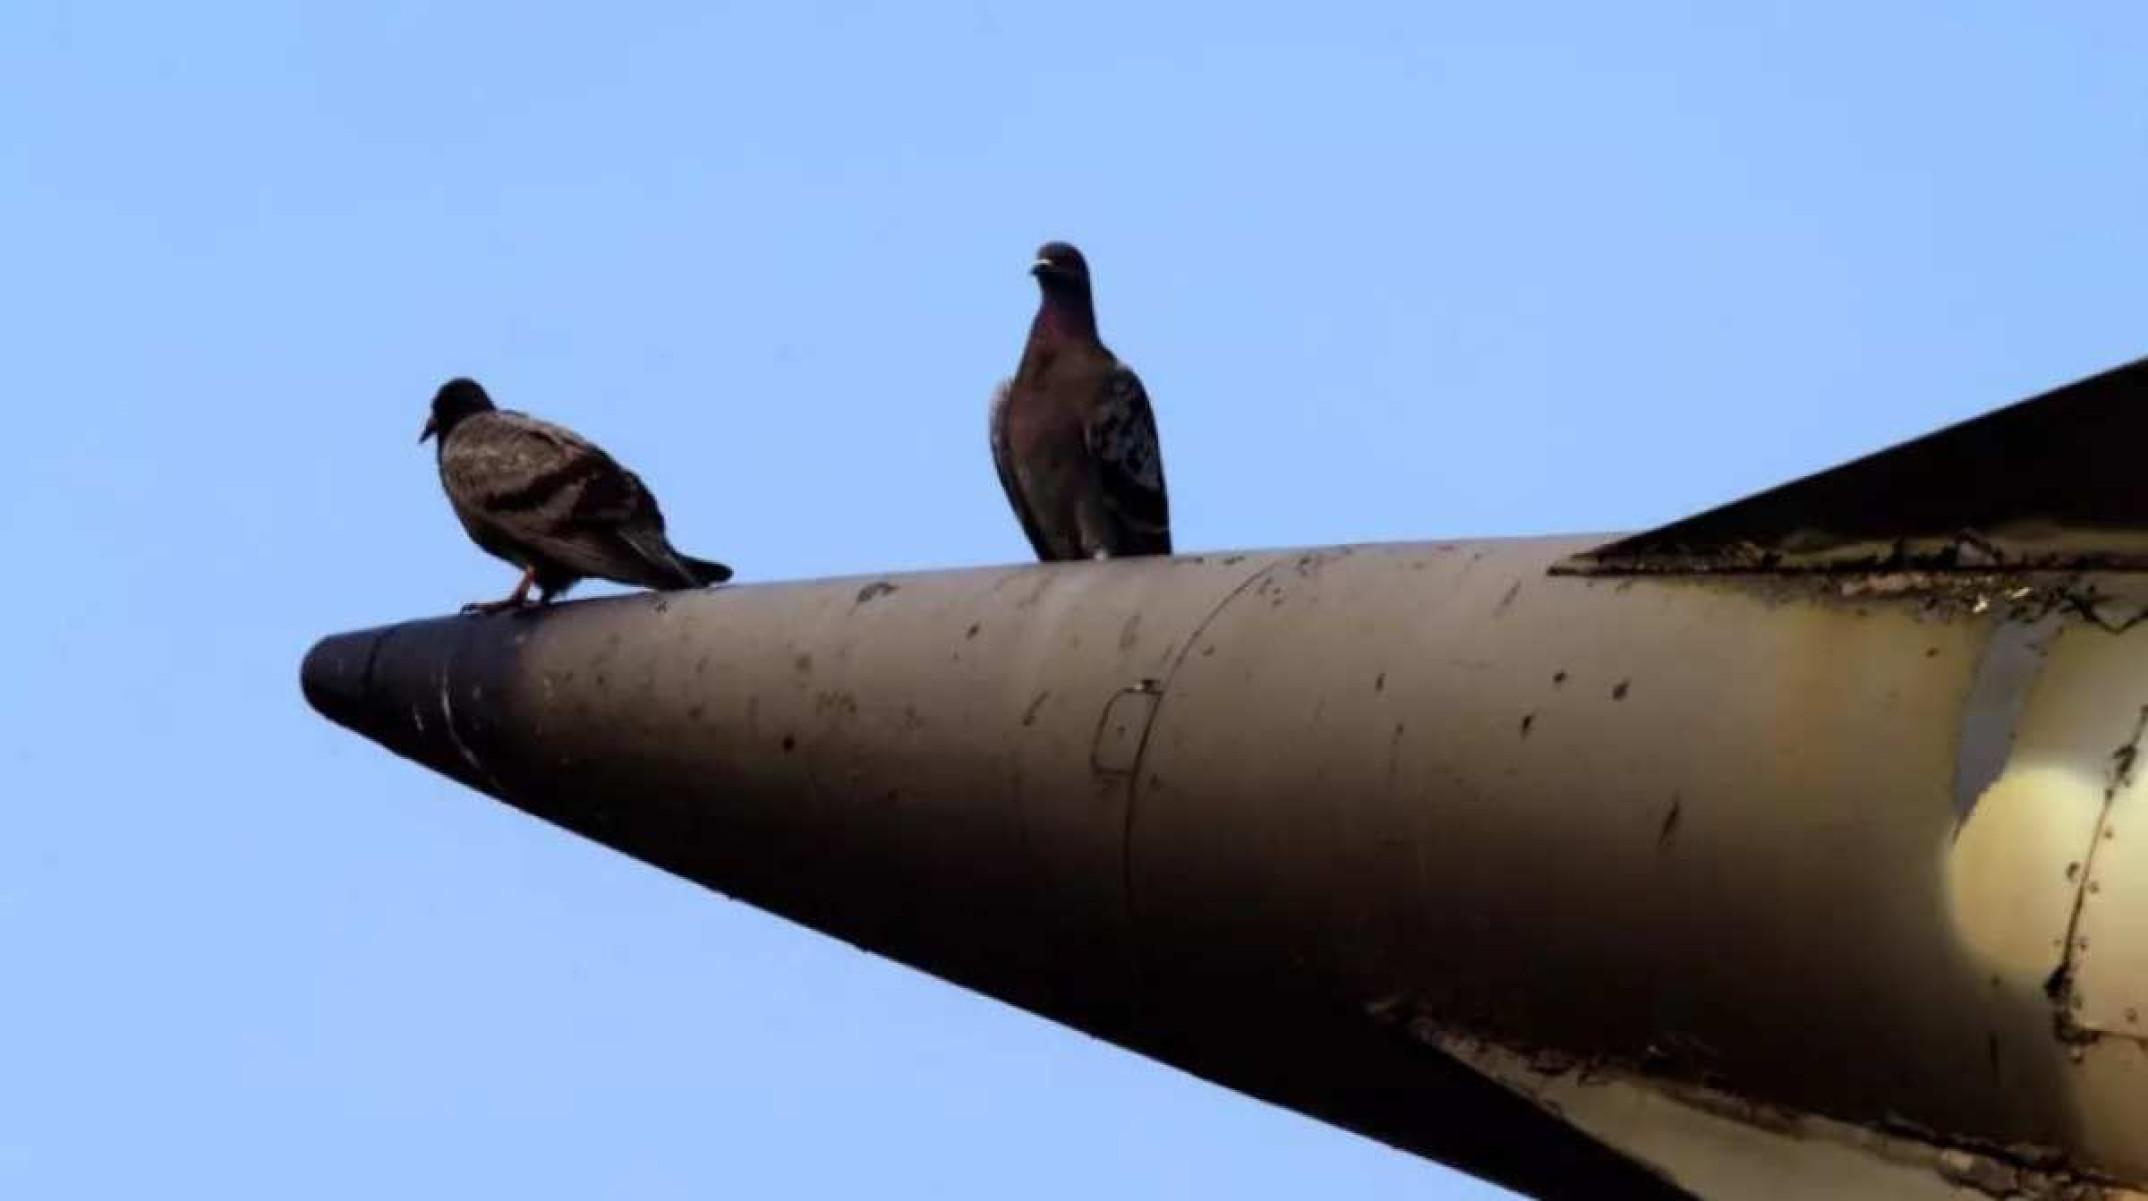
[305,539,2148,1197]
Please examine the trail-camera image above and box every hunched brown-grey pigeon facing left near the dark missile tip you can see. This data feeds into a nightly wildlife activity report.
[417,378,730,612]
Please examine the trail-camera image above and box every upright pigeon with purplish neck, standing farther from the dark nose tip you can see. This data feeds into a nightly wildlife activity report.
[992,243,1171,563]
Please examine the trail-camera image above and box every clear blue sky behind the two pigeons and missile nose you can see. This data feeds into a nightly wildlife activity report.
[0,0,2148,1201]
